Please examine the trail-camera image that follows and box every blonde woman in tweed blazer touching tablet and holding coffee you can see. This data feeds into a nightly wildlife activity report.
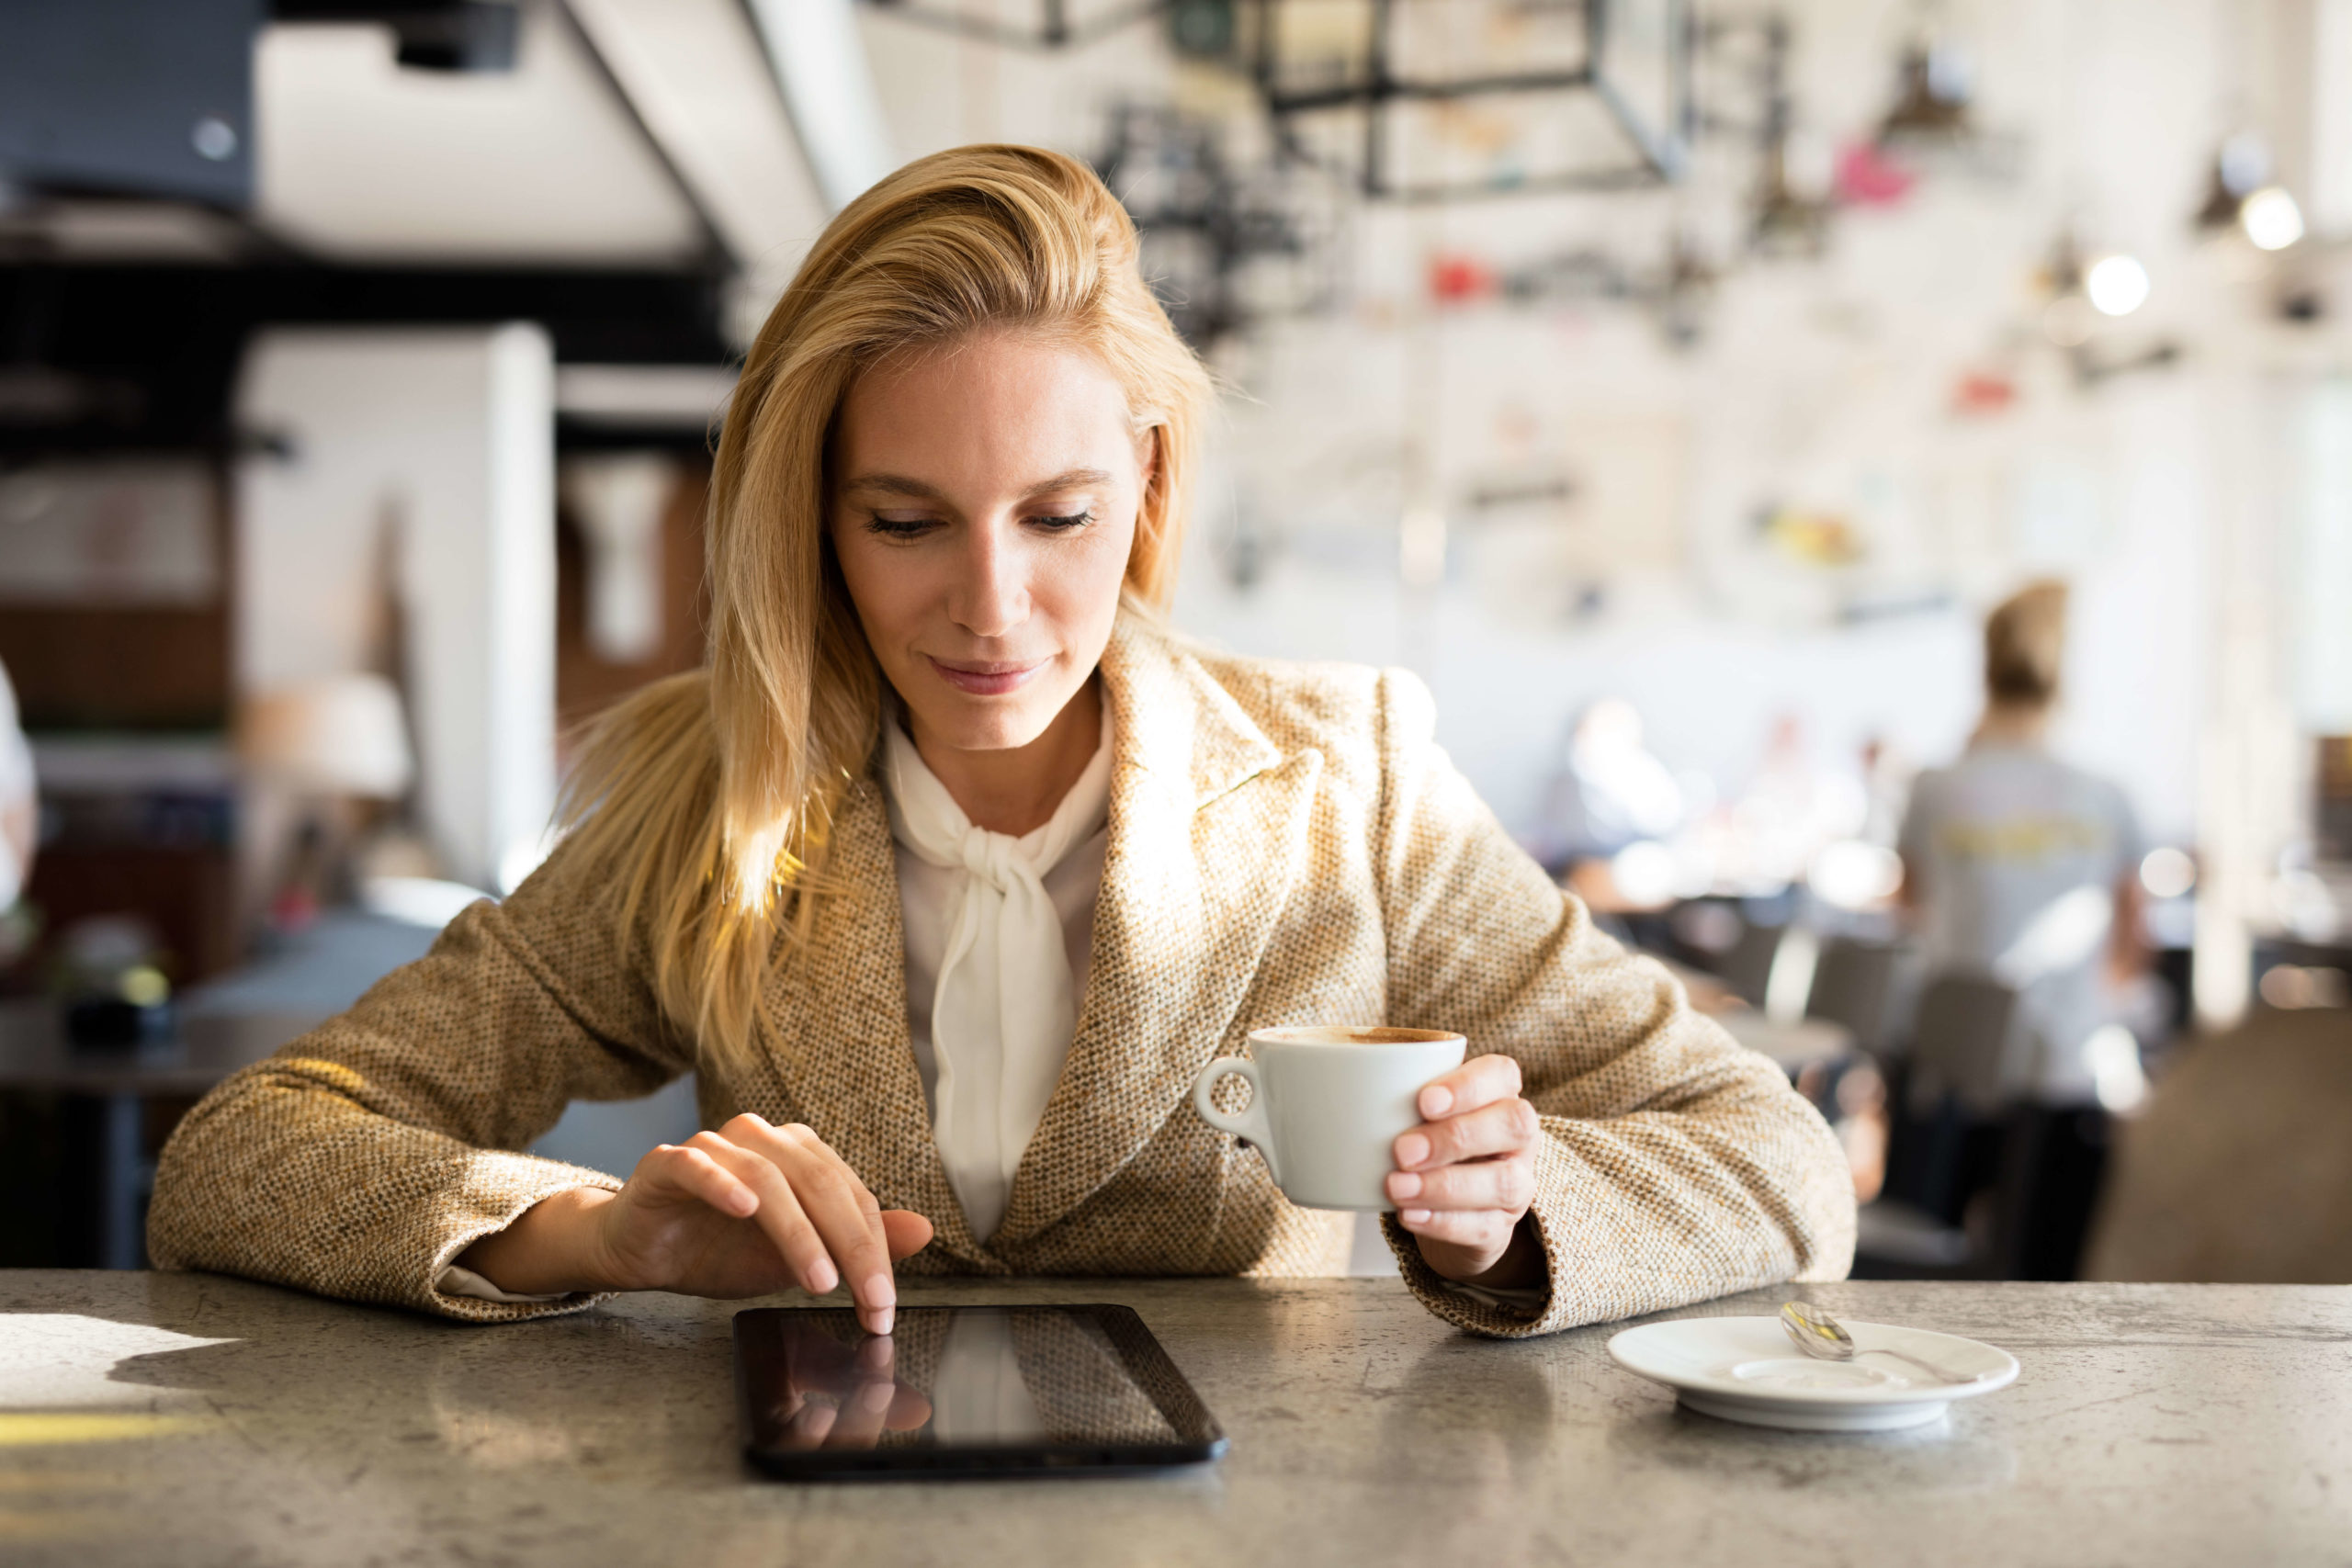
[151,148,1853,1336]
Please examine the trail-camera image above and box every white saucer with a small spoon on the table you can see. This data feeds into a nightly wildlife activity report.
[1609,1316,2018,1432]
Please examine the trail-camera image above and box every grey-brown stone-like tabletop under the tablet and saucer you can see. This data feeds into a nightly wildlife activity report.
[0,1272,2352,1568]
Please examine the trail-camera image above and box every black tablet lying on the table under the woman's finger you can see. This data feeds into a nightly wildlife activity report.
[736,1307,1226,1481]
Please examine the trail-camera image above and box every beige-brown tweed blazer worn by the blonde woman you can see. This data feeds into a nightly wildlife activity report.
[148,616,1853,1336]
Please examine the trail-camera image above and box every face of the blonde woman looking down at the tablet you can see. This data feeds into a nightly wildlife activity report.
[831,332,1152,752]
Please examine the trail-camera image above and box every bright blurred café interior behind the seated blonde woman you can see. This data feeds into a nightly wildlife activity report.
[0,0,2352,1279]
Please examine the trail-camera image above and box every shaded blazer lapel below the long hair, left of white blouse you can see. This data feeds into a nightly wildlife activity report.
[767,778,1004,1272]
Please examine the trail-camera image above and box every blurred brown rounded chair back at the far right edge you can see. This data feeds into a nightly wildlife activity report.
[2082,1009,2352,1283]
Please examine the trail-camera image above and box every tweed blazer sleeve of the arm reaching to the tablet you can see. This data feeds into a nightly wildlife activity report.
[148,831,692,1321]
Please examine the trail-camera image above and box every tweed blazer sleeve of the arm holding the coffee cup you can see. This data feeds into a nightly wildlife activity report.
[1374,672,1853,1336]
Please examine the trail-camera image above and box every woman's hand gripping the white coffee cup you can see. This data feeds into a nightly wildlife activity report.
[1387,1055,1545,1288]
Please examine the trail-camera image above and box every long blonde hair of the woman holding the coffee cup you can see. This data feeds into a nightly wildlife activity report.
[562,146,1209,1067]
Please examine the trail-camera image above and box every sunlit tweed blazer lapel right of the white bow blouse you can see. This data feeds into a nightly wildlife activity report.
[990,618,1322,1248]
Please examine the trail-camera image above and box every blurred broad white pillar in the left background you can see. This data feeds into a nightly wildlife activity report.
[235,324,555,891]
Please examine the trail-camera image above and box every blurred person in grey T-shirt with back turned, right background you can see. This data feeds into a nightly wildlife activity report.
[1898,581,2145,1279]
